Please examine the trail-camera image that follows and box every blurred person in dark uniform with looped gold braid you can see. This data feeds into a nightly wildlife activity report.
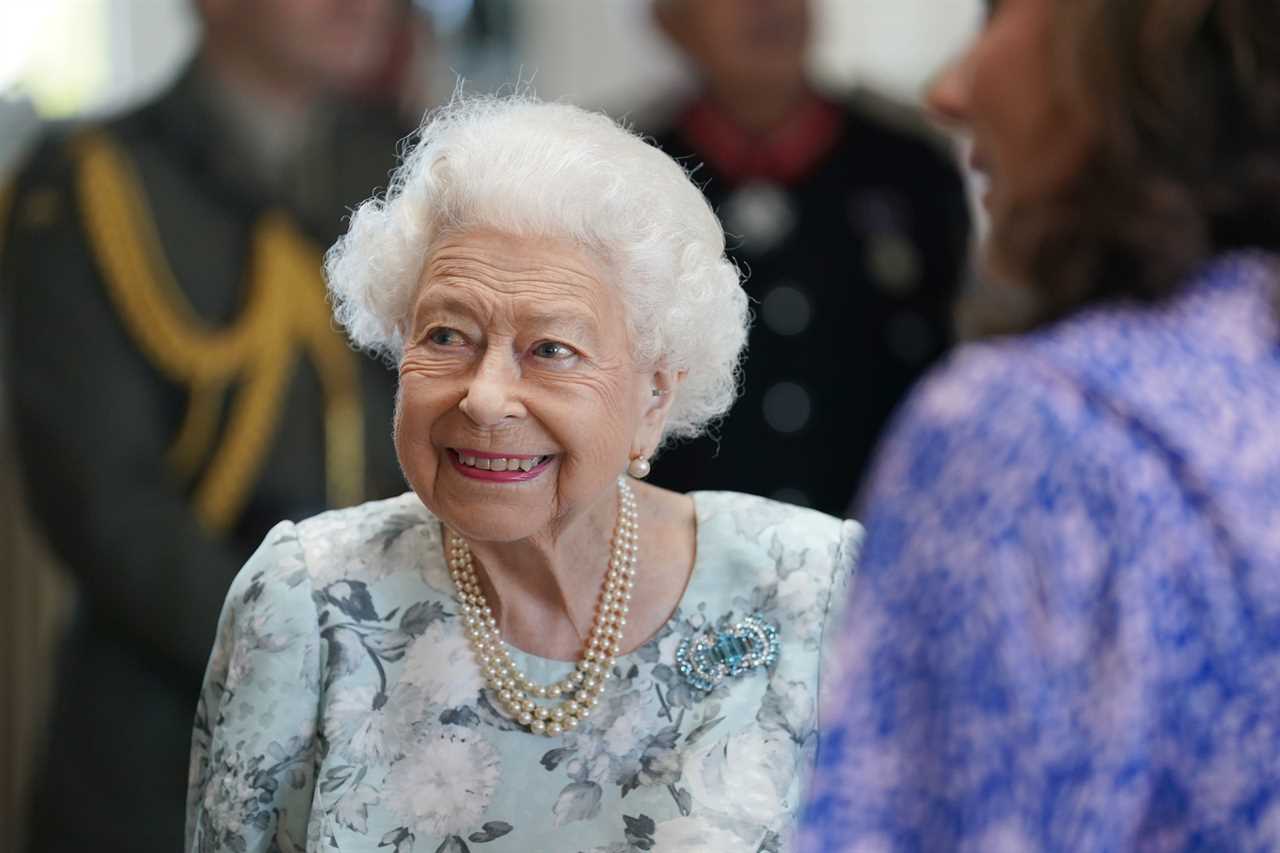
[0,0,424,853]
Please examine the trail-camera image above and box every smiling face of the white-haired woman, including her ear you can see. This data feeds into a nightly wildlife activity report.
[396,232,673,542]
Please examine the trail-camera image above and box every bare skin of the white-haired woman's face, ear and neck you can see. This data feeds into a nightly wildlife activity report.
[396,232,692,657]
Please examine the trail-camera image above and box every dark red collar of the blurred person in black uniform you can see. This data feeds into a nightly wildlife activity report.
[680,95,841,184]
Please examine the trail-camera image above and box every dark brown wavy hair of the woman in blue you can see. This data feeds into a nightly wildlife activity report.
[979,0,1280,333]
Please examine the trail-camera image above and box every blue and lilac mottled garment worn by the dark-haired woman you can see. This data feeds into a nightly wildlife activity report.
[797,254,1280,853]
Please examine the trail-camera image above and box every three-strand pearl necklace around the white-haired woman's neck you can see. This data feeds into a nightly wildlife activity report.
[449,478,640,736]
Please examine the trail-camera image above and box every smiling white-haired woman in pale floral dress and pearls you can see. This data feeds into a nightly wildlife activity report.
[188,97,858,853]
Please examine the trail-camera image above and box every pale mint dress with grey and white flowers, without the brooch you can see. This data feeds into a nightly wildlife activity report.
[187,492,860,853]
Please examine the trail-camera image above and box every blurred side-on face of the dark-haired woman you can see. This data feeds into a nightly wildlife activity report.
[929,0,1093,236]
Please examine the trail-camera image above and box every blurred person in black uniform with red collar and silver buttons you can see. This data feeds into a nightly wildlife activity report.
[653,0,969,515]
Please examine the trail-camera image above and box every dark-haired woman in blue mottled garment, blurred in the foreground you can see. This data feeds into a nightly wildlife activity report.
[801,0,1280,853]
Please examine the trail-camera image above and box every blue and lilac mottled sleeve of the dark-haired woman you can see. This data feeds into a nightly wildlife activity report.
[797,350,1162,853]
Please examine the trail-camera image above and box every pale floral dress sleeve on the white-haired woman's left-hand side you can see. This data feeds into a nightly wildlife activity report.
[187,523,321,853]
